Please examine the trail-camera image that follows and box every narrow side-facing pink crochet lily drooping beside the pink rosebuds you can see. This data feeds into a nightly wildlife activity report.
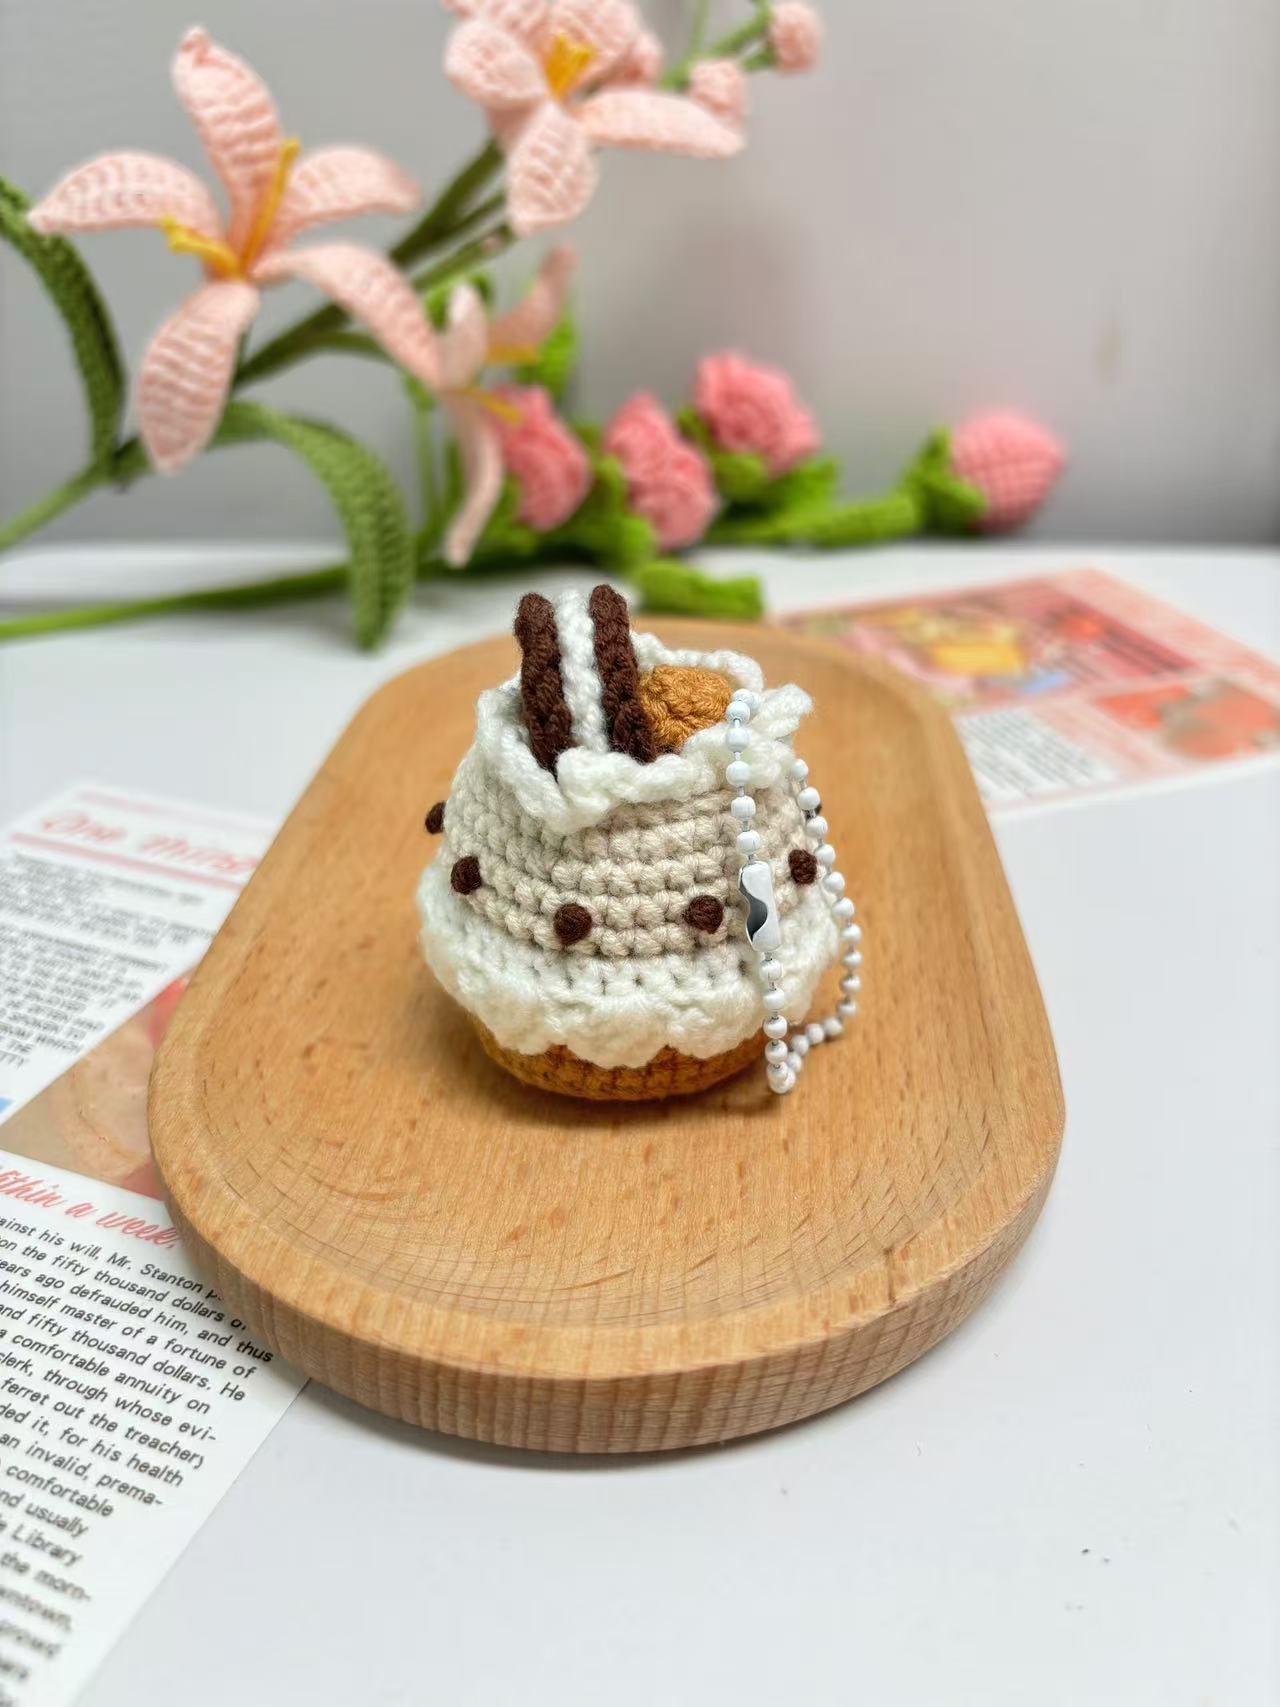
[435,249,575,568]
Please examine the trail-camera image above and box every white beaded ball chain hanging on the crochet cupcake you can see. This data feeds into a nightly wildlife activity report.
[725,688,862,1096]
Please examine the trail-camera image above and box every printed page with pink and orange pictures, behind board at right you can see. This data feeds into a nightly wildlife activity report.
[782,568,1280,814]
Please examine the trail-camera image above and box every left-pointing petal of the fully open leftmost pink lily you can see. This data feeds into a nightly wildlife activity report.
[31,152,222,239]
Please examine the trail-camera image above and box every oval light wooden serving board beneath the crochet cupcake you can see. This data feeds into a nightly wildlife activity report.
[150,623,1063,1453]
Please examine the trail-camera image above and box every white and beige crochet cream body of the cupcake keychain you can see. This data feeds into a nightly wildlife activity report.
[418,614,836,1067]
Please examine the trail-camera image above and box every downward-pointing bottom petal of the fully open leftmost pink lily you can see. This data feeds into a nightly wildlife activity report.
[138,278,259,475]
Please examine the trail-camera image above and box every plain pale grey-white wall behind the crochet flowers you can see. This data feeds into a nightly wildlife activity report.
[0,0,1280,541]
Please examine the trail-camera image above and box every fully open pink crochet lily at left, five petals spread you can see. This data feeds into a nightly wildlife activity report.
[31,29,433,473]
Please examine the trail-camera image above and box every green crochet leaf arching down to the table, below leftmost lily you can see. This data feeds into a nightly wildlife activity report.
[213,403,413,647]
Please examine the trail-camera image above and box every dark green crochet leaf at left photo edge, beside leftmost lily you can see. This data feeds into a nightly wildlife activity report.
[0,178,125,466]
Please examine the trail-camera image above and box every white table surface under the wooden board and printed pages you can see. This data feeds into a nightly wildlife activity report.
[0,546,1280,1707]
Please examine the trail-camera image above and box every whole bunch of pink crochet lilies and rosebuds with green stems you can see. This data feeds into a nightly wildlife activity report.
[0,0,1062,645]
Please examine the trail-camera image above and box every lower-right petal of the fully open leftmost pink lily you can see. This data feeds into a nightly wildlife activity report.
[253,242,440,387]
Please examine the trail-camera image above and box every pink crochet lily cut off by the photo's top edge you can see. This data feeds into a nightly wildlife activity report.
[444,0,742,237]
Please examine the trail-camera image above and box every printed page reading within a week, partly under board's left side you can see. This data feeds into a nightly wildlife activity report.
[0,785,300,1707]
